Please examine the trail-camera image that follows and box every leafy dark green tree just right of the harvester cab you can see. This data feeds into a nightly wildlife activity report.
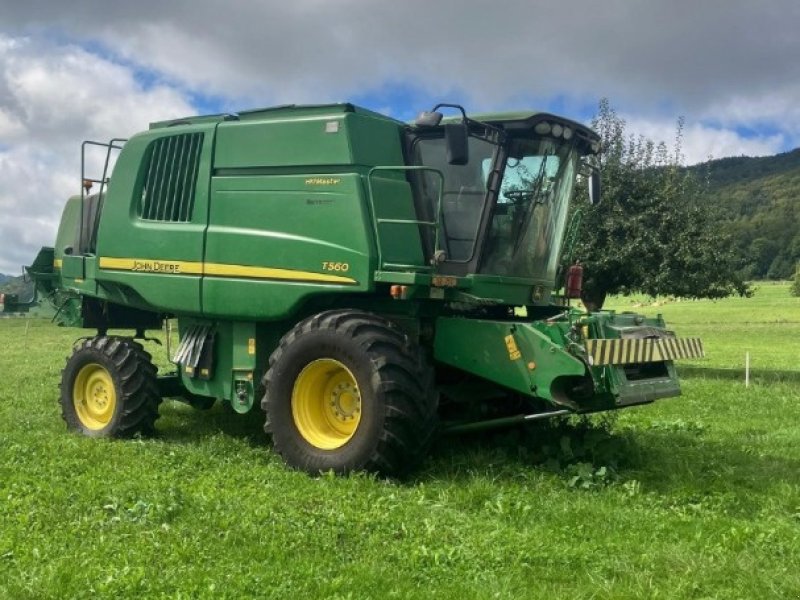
[574,99,749,310]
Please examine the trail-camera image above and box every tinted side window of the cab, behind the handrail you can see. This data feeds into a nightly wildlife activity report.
[414,137,497,262]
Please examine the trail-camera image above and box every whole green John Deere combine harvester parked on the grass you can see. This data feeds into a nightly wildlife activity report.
[28,104,702,475]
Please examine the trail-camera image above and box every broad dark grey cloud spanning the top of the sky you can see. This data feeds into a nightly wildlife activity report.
[4,0,800,127]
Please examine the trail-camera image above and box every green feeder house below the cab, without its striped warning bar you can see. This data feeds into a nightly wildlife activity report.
[434,312,680,412]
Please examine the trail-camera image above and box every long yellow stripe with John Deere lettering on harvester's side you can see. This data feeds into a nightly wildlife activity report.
[99,256,358,285]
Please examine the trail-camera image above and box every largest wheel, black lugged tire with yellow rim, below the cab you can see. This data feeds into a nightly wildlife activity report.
[261,310,437,476]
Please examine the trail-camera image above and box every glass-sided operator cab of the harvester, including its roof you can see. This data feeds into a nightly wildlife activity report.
[407,105,600,287]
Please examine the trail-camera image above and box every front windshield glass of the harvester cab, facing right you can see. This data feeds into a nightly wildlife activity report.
[479,139,578,282]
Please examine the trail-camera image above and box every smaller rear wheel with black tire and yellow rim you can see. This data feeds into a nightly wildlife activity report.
[61,336,161,437]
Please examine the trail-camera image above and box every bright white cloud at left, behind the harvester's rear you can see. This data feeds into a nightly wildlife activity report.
[0,35,194,273]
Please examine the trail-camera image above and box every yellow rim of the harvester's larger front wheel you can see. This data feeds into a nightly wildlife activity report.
[292,358,361,450]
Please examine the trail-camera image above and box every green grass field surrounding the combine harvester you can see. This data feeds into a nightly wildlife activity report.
[0,284,800,600]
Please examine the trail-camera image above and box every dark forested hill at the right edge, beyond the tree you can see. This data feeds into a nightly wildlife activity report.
[692,148,800,279]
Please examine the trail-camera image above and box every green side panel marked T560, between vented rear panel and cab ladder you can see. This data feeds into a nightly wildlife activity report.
[203,174,373,319]
